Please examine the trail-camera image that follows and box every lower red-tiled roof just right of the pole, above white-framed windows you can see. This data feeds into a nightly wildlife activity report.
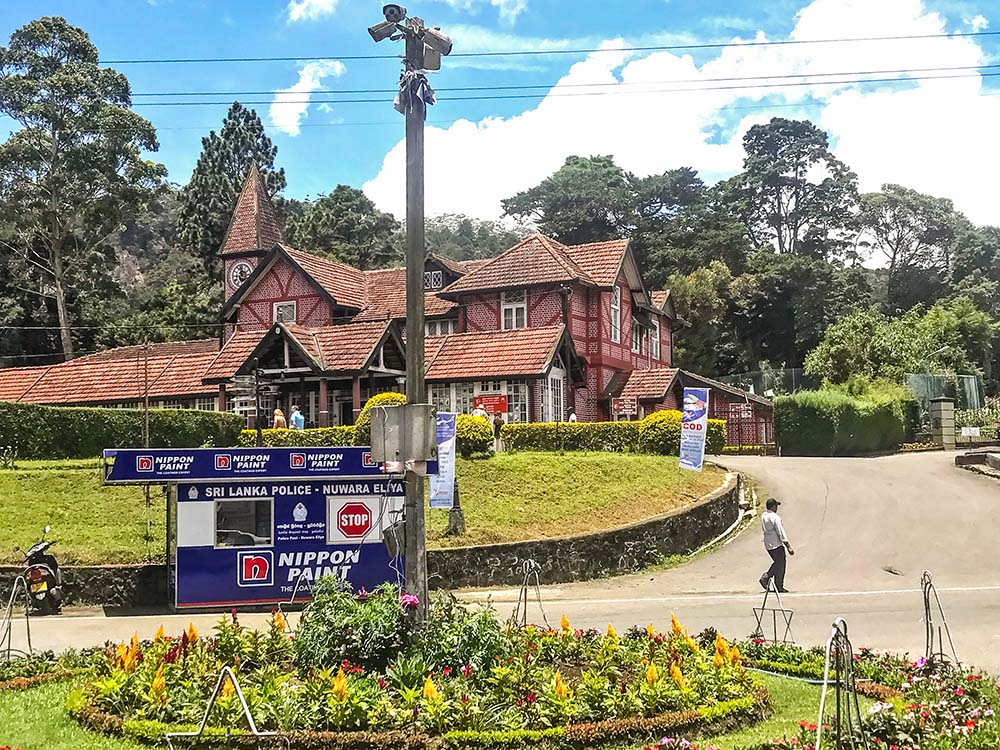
[424,325,565,380]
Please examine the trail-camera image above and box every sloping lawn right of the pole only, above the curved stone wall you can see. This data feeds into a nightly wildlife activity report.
[427,452,724,548]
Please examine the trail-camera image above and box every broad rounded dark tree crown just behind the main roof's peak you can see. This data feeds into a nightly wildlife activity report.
[502,156,629,245]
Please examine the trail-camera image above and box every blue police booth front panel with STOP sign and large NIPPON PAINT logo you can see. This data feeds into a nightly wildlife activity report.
[175,477,404,608]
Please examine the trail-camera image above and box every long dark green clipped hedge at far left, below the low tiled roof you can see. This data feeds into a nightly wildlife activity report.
[0,402,244,459]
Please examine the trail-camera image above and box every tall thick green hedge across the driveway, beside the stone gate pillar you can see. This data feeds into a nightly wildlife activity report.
[774,390,917,456]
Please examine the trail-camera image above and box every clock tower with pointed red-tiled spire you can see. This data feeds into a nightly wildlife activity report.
[219,164,284,300]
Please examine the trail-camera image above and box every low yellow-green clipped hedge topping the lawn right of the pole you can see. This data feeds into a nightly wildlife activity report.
[500,411,726,456]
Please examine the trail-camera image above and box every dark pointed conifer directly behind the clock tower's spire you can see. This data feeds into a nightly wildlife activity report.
[177,102,285,276]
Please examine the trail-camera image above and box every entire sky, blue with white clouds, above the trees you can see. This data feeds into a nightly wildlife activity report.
[0,0,1000,222]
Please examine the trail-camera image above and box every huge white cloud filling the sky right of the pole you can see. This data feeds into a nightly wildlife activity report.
[364,0,1000,223]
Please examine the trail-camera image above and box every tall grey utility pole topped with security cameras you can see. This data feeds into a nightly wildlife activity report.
[368,4,451,622]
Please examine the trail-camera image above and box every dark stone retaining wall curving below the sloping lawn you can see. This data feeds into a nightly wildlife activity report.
[0,473,739,607]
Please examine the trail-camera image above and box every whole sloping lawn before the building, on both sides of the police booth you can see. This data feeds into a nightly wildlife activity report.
[0,452,723,565]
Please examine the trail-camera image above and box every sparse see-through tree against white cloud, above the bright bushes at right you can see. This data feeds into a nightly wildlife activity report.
[860,184,967,311]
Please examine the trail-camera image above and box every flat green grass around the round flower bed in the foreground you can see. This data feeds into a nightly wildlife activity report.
[0,675,844,750]
